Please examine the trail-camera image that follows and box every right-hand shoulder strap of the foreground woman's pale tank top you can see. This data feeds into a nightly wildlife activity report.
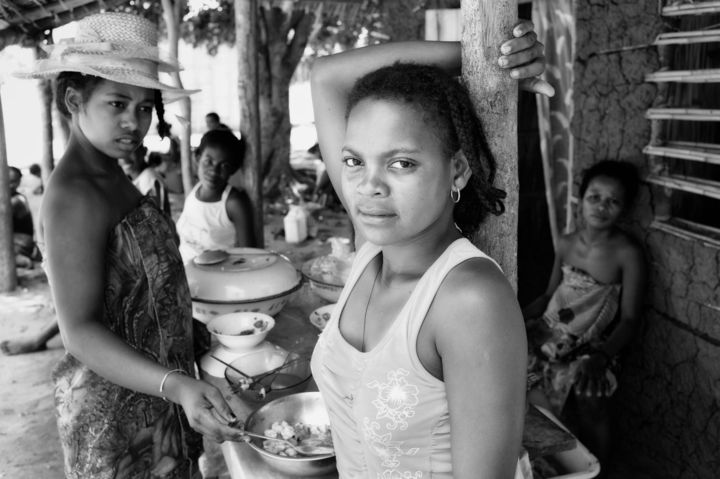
[407,238,502,334]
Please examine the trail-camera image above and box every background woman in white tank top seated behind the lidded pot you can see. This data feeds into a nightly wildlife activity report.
[177,129,255,263]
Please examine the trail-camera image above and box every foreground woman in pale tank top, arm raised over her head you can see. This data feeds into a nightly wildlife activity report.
[312,24,543,479]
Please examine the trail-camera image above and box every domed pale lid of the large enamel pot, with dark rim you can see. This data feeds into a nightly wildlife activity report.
[185,248,302,302]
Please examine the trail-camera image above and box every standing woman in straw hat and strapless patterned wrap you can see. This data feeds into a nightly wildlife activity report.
[14,13,243,478]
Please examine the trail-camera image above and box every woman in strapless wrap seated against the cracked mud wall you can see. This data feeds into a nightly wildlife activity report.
[523,160,646,462]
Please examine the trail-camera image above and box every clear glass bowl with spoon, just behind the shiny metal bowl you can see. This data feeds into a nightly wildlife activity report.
[225,348,312,403]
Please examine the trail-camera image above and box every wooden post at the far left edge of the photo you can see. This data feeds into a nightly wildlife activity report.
[0,89,17,293]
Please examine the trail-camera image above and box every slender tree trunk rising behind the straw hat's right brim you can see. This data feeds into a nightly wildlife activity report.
[162,0,193,195]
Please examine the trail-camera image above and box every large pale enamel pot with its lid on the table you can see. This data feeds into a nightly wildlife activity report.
[185,248,302,323]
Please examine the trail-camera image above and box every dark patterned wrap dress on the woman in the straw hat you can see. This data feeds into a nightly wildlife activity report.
[53,197,202,479]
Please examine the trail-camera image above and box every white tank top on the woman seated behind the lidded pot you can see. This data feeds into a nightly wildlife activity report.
[177,183,235,263]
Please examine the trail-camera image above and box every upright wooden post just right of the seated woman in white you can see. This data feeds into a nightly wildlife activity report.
[235,0,265,248]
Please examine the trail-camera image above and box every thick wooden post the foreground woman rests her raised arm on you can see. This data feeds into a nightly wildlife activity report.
[460,0,519,288]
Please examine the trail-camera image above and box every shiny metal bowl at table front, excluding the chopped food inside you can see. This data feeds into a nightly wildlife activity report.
[245,392,335,476]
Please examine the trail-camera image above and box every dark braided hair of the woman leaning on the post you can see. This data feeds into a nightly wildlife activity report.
[345,63,506,236]
